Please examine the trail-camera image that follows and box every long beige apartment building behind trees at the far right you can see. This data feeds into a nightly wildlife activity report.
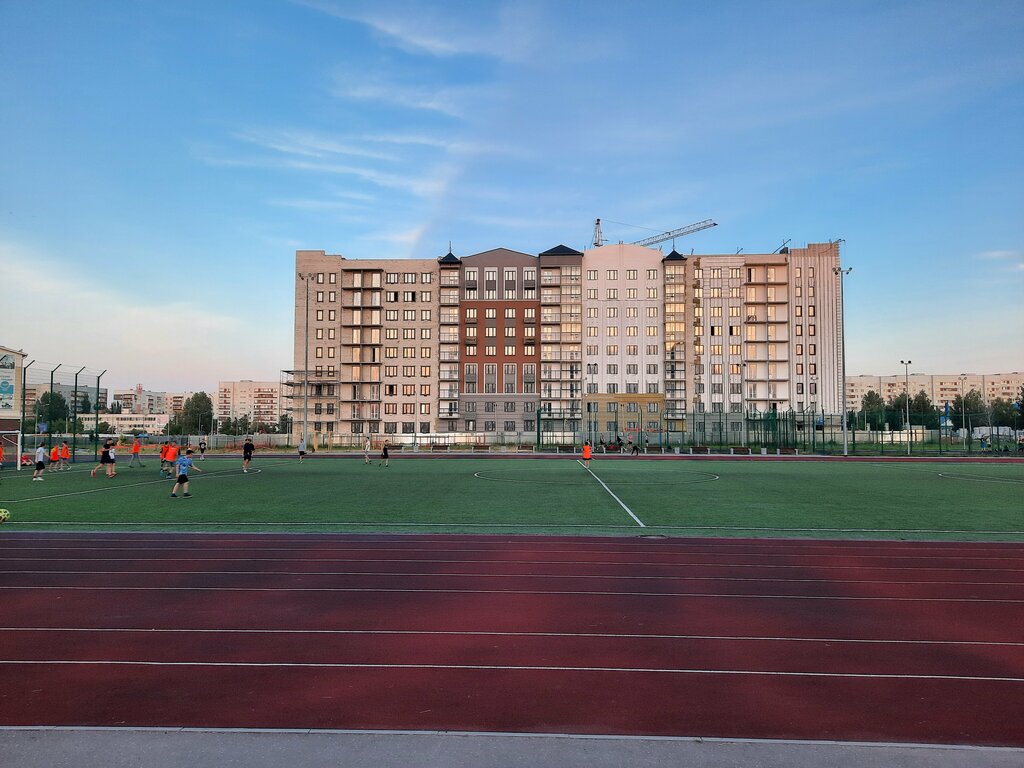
[846,371,1024,411]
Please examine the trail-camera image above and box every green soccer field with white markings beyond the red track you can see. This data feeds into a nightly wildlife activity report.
[0,456,1024,542]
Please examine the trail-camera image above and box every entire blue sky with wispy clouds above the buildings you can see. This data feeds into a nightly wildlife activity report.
[0,0,1024,390]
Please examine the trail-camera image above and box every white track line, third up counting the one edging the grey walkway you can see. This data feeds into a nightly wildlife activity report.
[0,627,1024,647]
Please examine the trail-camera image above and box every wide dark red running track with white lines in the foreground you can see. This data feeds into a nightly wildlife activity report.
[0,534,1024,746]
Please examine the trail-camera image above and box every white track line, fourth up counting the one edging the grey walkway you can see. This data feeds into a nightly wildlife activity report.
[4,584,1024,605]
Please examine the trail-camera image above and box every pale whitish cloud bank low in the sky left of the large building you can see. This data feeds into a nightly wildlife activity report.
[0,242,292,392]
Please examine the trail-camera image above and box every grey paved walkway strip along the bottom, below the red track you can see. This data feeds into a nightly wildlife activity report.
[0,728,1024,768]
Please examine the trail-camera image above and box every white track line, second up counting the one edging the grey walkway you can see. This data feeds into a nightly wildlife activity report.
[0,658,1024,683]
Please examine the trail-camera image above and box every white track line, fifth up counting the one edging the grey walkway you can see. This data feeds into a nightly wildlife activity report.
[0,568,1024,588]
